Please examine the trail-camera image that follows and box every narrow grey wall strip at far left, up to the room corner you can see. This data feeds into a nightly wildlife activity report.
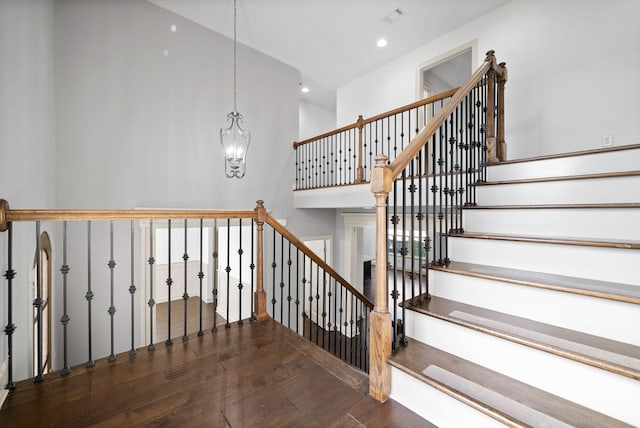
[0,0,55,388]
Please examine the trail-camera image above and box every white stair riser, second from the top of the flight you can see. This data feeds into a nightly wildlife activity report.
[476,176,640,205]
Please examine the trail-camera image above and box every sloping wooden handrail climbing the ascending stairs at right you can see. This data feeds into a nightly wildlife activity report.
[390,51,506,179]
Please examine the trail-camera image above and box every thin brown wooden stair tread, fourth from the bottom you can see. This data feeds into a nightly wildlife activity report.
[449,231,640,250]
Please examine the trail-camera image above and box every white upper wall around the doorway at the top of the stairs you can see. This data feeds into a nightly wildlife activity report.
[337,0,640,158]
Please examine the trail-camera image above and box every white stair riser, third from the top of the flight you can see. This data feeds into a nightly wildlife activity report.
[463,208,640,241]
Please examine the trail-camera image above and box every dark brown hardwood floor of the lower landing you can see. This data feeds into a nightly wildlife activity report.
[0,320,433,427]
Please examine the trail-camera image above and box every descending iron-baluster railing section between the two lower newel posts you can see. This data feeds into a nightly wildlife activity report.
[269,219,373,372]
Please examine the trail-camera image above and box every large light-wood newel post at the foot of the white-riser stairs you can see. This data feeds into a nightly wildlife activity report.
[369,155,392,402]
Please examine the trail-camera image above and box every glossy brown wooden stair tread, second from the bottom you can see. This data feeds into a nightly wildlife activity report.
[404,296,640,379]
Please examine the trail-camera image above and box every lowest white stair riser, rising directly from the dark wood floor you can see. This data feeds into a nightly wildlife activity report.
[391,367,504,428]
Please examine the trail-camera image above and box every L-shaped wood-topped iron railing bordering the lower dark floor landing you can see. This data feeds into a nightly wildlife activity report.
[0,200,372,389]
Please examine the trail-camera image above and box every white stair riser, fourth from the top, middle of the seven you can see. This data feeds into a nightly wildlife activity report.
[449,238,640,285]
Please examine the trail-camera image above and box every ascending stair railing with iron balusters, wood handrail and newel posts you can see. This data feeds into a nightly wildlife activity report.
[369,51,507,400]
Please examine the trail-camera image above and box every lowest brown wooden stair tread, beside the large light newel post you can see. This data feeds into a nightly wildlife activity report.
[389,340,629,427]
